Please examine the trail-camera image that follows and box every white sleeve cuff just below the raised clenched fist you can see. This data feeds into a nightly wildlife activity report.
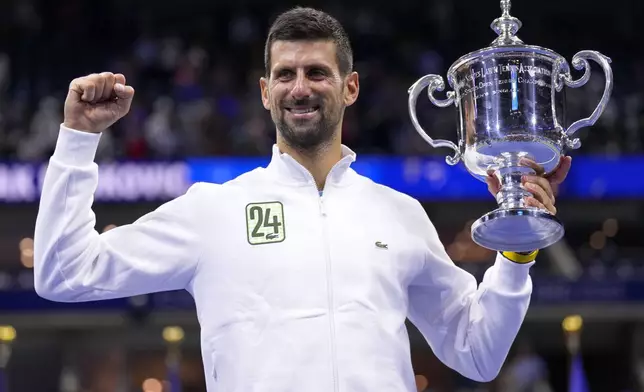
[52,124,101,166]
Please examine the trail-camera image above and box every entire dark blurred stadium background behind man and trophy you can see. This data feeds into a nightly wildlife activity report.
[0,0,644,392]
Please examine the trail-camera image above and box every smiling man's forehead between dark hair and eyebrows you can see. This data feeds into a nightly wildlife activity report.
[271,40,336,68]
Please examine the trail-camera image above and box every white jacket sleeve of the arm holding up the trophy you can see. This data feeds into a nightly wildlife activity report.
[408,201,534,382]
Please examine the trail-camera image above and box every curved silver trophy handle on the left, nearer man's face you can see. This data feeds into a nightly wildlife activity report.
[408,75,461,166]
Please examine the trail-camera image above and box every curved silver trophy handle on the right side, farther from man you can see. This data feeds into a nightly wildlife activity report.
[555,50,613,149]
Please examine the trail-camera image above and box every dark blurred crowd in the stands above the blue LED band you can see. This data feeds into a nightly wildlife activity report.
[0,0,644,161]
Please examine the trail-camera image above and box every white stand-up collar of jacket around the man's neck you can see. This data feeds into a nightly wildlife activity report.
[267,144,356,185]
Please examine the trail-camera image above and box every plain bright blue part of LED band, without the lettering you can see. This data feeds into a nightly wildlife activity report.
[187,156,644,200]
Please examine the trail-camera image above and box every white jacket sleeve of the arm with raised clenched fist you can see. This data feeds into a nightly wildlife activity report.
[34,126,200,302]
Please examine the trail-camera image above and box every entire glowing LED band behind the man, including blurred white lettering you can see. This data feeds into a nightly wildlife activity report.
[0,155,644,203]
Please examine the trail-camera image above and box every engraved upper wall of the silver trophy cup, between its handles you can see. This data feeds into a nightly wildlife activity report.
[453,54,565,153]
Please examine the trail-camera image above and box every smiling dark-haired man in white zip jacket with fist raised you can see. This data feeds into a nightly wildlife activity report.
[34,8,570,392]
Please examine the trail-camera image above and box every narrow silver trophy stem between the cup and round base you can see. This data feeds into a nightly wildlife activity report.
[494,153,535,209]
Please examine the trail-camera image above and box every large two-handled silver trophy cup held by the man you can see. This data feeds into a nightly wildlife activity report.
[409,0,613,252]
